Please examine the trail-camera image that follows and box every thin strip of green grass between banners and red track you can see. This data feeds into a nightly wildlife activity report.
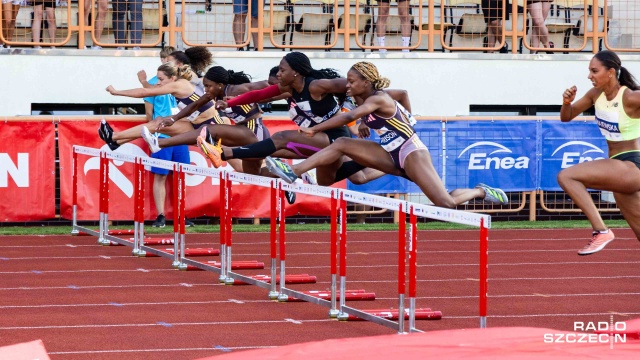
[0,220,629,235]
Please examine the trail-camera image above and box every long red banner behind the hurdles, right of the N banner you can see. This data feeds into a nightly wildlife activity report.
[58,120,344,220]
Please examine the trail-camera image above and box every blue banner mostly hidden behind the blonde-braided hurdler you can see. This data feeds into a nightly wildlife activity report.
[347,120,442,194]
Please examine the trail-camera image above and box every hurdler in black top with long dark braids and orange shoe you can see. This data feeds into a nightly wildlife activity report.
[200,52,404,185]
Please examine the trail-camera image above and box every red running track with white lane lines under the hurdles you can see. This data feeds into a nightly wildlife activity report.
[0,229,640,359]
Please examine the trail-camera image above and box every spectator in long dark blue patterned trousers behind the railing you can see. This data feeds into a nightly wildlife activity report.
[112,0,142,50]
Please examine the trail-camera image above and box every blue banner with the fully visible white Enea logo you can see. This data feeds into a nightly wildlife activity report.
[444,120,538,191]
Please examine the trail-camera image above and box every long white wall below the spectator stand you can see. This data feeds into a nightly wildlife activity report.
[0,49,640,116]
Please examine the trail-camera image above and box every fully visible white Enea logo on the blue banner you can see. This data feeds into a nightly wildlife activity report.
[458,141,529,170]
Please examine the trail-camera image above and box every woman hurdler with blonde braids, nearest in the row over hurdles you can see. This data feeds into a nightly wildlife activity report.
[267,61,509,208]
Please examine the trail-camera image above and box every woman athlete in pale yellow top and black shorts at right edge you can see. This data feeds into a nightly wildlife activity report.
[558,50,640,255]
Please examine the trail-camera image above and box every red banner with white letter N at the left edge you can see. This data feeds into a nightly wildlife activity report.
[0,120,56,222]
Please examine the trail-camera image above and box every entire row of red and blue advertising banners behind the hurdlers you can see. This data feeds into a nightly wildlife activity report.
[0,117,607,222]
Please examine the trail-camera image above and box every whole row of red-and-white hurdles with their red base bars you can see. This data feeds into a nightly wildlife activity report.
[73,146,491,333]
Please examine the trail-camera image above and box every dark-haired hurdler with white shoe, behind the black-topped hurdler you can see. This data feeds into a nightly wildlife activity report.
[141,66,269,174]
